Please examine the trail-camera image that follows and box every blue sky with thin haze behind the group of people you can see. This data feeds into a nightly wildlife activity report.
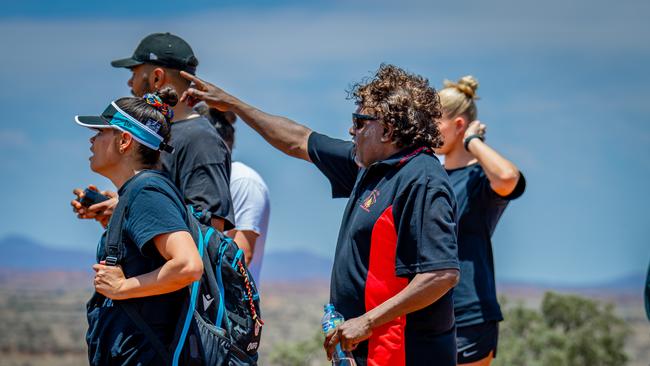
[0,0,650,284]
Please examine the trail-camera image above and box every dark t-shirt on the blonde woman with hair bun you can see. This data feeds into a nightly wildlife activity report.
[447,164,526,327]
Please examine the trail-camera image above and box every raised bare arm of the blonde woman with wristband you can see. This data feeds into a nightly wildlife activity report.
[465,121,519,197]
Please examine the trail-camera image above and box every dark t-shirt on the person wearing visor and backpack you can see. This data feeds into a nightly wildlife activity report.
[86,172,188,365]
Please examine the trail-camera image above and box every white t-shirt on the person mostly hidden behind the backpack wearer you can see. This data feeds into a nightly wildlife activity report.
[230,161,271,286]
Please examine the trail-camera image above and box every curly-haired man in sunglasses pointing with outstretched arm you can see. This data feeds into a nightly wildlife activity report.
[181,65,459,366]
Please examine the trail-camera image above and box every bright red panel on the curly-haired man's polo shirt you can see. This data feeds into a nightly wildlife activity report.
[365,206,408,366]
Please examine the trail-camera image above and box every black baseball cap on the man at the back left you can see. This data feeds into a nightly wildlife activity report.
[111,32,199,74]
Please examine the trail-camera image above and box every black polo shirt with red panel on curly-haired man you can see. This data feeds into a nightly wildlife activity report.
[308,133,459,365]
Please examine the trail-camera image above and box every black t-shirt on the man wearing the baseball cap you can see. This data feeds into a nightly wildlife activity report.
[161,117,235,230]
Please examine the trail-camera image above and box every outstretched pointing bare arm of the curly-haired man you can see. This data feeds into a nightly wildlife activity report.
[181,71,312,161]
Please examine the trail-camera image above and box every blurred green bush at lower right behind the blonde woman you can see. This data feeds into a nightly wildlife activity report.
[493,292,630,366]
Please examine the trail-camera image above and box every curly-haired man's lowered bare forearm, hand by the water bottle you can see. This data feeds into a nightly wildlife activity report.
[324,269,459,357]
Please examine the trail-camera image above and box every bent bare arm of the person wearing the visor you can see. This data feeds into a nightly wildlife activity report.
[93,231,203,300]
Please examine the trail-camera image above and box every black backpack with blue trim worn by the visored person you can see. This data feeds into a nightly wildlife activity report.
[105,171,264,366]
